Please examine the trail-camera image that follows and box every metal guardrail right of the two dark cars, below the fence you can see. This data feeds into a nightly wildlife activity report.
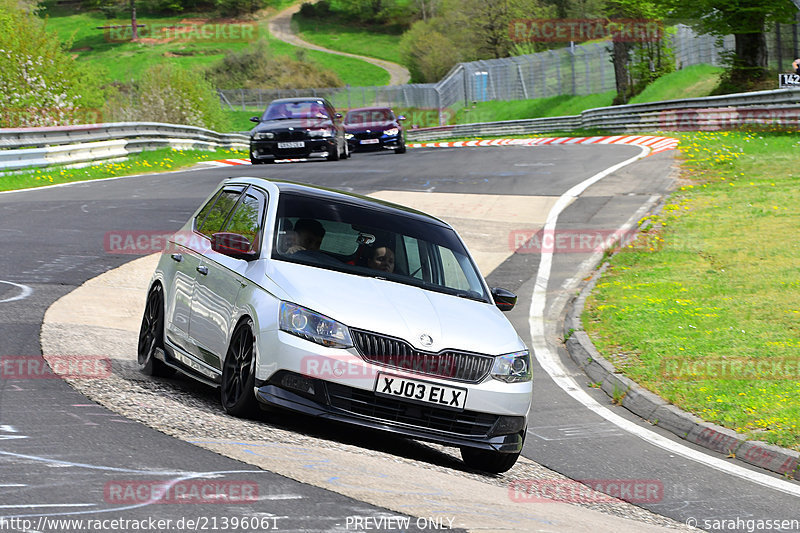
[408,85,800,142]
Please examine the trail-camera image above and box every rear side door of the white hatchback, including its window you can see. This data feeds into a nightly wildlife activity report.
[164,185,244,352]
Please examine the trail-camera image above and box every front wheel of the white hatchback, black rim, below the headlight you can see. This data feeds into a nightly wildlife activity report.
[220,319,258,417]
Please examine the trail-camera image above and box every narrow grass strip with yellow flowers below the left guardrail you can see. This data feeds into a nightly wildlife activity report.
[0,148,248,191]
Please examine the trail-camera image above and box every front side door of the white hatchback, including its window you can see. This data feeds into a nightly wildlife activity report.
[189,187,267,369]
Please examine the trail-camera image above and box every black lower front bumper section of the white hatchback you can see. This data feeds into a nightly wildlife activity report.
[256,371,526,453]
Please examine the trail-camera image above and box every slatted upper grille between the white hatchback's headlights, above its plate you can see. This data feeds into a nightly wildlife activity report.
[351,330,494,383]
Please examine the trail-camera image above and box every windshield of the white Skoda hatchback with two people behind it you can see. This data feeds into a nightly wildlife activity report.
[272,193,491,303]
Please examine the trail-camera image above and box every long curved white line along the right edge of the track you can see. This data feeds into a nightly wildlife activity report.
[529,146,800,496]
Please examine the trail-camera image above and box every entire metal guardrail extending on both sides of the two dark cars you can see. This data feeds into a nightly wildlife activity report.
[0,89,800,170]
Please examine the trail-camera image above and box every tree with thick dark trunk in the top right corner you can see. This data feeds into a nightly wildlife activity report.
[667,0,797,85]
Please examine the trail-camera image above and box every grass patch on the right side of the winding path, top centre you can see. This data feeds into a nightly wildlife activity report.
[292,13,402,64]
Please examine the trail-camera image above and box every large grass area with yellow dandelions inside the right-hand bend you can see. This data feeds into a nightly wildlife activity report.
[584,132,800,450]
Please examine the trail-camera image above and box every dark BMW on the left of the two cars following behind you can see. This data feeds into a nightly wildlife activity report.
[250,97,350,165]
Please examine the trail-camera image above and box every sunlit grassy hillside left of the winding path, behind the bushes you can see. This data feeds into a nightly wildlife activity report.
[41,8,389,86]
